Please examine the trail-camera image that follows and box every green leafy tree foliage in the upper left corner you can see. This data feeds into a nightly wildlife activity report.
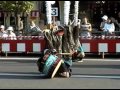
[0,1,34,13]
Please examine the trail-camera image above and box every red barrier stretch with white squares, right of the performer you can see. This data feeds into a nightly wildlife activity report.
[80,36,120,53]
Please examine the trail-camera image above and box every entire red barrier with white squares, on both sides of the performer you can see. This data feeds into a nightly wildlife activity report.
[0,36,120,53]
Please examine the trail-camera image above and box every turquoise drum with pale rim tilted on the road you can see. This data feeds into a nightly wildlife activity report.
[43,54,63,78]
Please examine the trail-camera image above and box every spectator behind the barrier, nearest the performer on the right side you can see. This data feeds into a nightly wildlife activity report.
[80,17,92,38]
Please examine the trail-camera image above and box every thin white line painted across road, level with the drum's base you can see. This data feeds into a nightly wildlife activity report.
[0,73,120,79]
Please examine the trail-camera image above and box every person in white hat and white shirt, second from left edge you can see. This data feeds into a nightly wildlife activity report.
[3,26,17,40]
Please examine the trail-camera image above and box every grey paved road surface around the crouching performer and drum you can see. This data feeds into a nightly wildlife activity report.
[0,58,120,89]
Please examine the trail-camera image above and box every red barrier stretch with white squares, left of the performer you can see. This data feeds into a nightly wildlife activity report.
[0,36,46,53]
